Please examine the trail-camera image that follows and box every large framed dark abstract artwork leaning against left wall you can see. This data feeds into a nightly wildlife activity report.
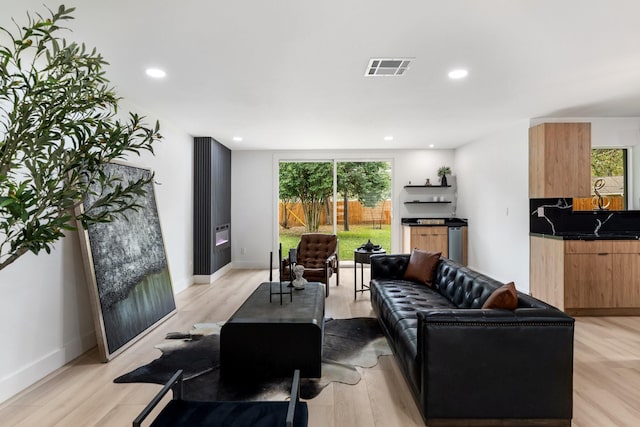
[76,162,176,362]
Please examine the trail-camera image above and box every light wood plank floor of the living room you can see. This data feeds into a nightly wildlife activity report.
[0,268,640,427]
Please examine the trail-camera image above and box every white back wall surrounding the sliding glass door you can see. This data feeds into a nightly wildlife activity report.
[231,150,456,268]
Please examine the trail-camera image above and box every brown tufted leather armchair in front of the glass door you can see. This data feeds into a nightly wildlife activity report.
[280,233,340,296]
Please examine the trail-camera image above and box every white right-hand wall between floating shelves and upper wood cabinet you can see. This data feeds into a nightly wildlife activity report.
[455,120,529,292]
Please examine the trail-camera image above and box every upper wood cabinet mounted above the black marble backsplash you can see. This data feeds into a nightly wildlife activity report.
[529,123,591,199]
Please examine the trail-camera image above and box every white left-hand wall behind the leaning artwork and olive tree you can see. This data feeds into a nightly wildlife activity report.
[0,113,193,402]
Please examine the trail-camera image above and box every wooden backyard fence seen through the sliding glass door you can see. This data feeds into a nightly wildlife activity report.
[278,200,391,227]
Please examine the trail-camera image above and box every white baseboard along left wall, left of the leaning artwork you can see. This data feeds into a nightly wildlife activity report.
[0,332,96,403]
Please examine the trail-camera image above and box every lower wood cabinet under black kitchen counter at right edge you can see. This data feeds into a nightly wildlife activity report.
[530,237,640,315]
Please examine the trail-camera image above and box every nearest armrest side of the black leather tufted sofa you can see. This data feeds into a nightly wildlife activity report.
[417,308,573,419]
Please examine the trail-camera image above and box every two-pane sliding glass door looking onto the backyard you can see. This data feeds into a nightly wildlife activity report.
[278,160,391,261]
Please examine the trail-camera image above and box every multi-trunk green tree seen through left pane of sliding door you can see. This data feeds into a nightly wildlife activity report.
[280,162,333,232]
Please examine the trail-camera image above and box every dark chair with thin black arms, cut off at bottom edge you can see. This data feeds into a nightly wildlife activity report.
[133,370,309,427]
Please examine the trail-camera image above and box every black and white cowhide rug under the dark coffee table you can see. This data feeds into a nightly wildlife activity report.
[114,317,391,401]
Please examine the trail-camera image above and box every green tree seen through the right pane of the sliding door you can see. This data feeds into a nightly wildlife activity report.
[337,162,391,231]
